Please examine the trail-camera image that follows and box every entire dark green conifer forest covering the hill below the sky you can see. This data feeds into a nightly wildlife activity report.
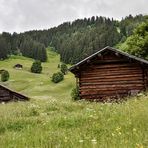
[0,15,148,64]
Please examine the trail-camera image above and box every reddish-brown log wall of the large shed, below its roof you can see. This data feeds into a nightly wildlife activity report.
[79,55,145,101]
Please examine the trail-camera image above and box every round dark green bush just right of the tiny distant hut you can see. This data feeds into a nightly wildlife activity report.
[31,61,42,73]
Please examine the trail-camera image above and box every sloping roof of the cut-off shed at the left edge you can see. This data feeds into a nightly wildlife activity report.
[0,84,29,100]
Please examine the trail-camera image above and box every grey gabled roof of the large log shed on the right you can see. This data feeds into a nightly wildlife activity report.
[69,46,148,72]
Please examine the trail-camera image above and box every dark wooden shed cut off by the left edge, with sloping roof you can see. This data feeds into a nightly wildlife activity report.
[0,85,29,103]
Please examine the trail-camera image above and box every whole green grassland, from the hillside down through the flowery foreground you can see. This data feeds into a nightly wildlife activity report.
[0,49,148,148]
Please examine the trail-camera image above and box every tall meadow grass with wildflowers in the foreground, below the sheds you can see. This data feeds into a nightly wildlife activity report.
[0,96,148,148]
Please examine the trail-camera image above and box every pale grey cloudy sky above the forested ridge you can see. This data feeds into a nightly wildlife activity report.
[0,0,148,32]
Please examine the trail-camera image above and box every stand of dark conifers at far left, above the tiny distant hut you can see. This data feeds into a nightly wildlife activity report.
[0,32,47,62]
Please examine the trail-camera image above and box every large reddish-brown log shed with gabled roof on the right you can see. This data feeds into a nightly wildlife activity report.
[70,47,148,101]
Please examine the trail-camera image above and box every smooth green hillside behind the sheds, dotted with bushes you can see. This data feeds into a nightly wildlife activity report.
[0,48,75,99]
